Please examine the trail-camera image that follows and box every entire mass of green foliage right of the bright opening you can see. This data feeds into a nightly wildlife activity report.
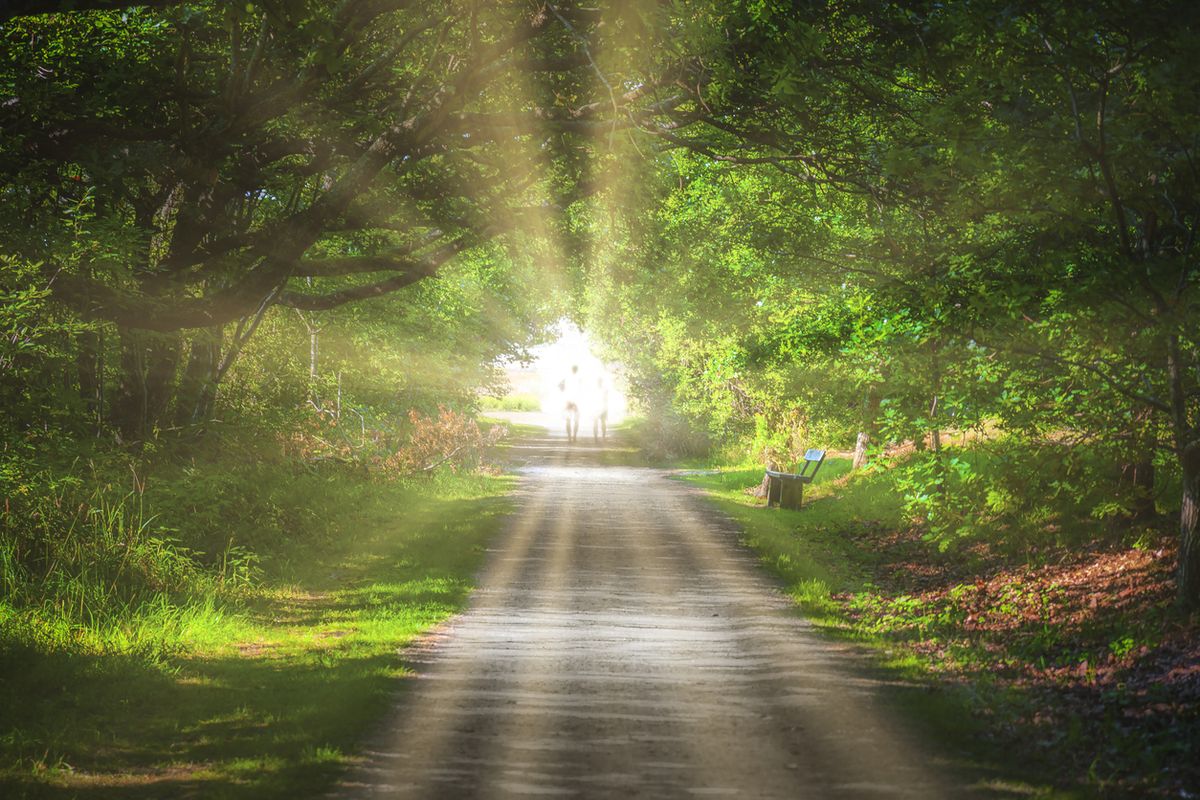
[577,0,1200,603]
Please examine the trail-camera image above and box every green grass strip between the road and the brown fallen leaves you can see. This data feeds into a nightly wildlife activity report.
[684,458,1086,799]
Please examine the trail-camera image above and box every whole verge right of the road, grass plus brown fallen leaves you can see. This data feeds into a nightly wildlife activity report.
[686,459,1200,798]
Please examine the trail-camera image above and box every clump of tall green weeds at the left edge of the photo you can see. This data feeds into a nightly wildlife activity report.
[0,450,229,661]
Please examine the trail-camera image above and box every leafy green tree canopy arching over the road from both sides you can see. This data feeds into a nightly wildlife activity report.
[7,0,1200,602]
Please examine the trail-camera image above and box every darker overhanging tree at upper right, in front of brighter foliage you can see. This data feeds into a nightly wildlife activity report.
[614,1,1200,599]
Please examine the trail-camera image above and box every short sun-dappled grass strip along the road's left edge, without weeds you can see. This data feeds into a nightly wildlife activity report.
[0,475,509,800]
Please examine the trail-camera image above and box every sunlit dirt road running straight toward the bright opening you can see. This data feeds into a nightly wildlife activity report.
[335,429,962,799]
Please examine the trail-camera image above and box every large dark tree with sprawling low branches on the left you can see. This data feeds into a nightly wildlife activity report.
[0,0,696,435]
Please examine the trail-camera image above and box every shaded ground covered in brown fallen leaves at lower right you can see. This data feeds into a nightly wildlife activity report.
[838,525,1200,798]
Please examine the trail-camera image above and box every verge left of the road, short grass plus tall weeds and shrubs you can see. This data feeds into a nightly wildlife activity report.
[0,431,511,798]
